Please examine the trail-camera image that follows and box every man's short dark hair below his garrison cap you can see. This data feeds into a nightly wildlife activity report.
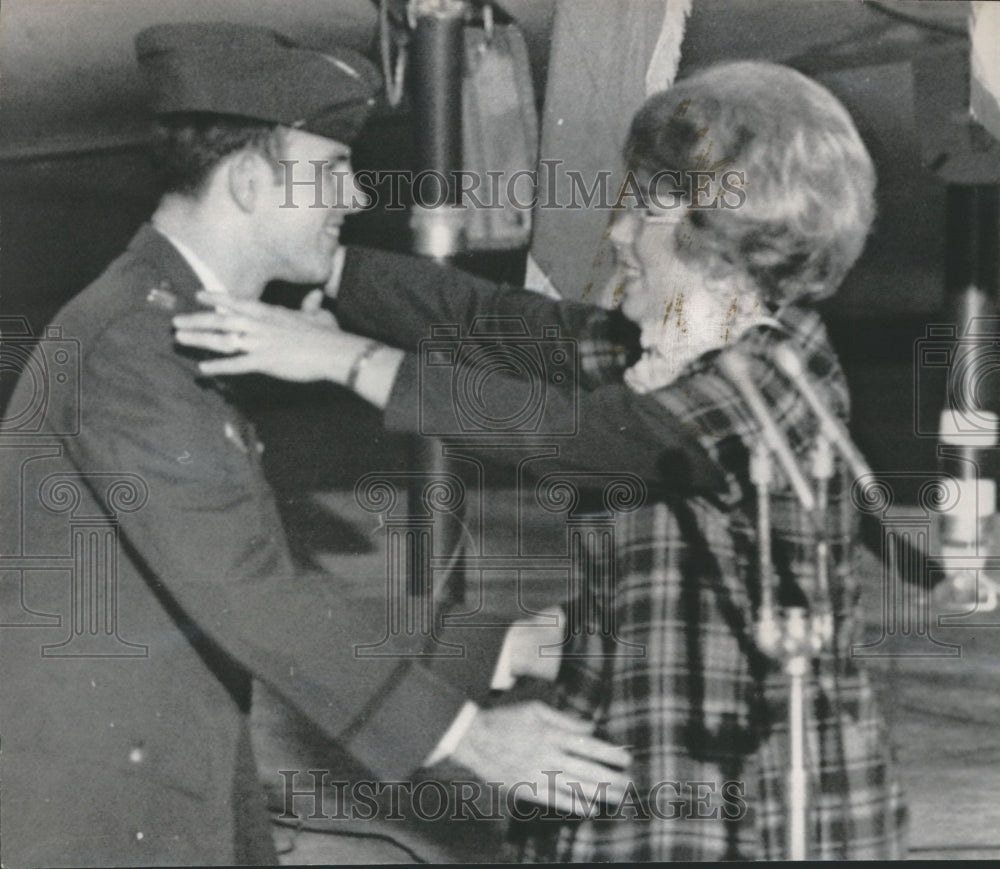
[150,112,282,196]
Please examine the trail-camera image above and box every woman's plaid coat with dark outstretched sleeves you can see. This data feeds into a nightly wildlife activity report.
[337,249,904,861]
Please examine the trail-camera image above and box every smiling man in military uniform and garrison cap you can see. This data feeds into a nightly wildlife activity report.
[0,24,627,867]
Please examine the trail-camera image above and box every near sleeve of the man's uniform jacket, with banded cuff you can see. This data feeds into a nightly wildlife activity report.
[67,312,494,777]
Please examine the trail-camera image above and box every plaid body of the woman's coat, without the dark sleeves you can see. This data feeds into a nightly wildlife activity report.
[514,310,905,861]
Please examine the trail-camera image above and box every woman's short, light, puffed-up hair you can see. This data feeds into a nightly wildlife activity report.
[625,61,875,308]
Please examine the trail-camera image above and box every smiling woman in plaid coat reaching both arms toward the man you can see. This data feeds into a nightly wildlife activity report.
[172,62,904,861]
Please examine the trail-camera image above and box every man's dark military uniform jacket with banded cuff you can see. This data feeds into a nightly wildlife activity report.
[0,226,500,867]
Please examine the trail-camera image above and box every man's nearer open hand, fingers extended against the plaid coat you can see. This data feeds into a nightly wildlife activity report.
[451,700,631,815]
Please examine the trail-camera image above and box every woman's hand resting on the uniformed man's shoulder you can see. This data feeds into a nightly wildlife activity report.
[174,290,368,382]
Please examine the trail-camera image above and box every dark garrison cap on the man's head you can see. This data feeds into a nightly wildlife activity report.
[135,21,381,142]
